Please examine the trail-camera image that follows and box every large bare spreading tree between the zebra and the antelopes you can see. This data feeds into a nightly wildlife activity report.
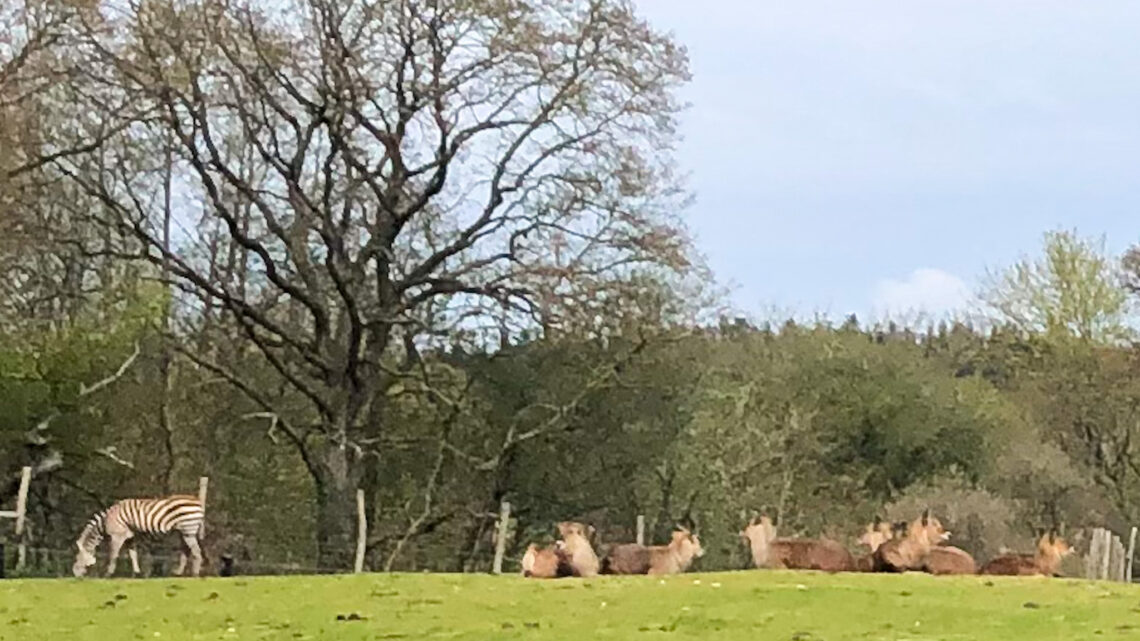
[66,0,689,568]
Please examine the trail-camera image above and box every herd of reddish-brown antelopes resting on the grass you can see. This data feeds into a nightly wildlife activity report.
[522,510,1072,578]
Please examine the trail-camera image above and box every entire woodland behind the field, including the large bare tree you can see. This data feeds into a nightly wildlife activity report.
[0,0,1140,571]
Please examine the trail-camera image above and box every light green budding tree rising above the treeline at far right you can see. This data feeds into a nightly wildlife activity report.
[983,232,1140,525]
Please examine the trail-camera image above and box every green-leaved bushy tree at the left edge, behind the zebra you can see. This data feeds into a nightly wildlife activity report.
[0,291,157,556]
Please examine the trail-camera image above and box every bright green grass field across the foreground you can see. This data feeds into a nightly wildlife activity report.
[0,571,1140,641]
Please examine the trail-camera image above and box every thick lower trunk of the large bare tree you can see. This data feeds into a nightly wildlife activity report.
[316,437,364,571]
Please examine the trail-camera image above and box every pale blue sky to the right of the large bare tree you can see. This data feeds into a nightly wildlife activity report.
[638,0,1140,317]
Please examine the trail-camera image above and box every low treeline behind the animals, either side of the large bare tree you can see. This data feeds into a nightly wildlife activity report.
[0,261,1140,571]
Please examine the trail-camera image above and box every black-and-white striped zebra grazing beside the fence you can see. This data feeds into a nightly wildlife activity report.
[72,496,205,577]
